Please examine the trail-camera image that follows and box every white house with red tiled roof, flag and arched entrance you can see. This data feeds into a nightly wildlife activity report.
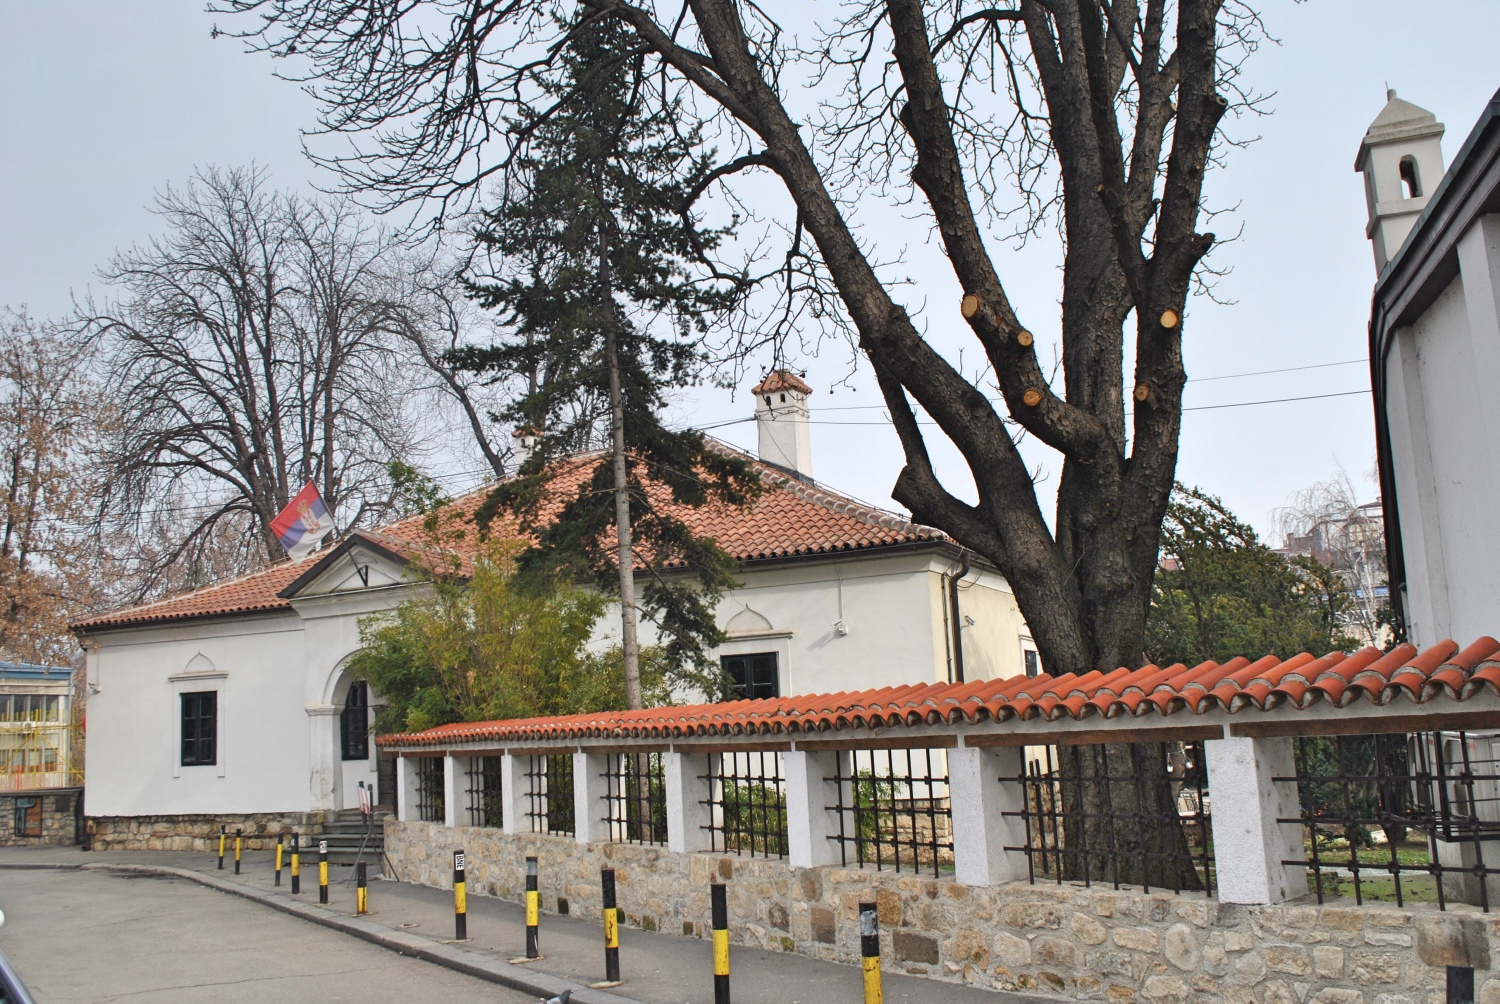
[75,374,1035,846]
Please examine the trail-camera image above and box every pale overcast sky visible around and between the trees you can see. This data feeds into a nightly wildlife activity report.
[0,0,1500,531]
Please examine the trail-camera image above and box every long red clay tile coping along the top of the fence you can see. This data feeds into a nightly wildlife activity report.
[377,636,1500,747]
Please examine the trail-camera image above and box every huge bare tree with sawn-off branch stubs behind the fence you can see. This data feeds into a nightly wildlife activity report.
[216,0,1263,882]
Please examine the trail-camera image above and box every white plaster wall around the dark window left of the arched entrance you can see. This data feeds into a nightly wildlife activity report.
[84,614,311,816]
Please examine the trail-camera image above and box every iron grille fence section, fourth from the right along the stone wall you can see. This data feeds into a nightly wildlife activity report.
[699,752,786,857]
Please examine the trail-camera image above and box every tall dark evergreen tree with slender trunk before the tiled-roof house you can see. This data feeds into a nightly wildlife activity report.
[453,20,759,708]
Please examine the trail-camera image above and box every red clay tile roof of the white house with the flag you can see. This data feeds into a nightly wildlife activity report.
[72,447,947,633]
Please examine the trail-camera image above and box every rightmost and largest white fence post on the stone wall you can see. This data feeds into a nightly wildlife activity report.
[1203,737,1308,903]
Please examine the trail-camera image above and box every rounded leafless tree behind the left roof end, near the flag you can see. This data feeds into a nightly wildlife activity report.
[81,168,419,590]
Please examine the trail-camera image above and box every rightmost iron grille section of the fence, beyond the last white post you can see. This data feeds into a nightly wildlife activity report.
[1274,731,1500,912]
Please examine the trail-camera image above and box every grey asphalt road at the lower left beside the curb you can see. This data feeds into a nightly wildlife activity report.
[0,869,534,1004]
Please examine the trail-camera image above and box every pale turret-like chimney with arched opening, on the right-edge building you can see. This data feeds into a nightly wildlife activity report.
[1355,90,1443,275]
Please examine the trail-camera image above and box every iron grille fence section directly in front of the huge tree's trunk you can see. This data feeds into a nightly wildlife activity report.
[1001,741,1214,893]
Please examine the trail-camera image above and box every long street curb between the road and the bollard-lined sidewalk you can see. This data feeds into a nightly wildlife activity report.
[77,861,642,1004]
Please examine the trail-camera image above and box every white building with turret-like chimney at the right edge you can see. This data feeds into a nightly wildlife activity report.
[1355,92,1500,645]
